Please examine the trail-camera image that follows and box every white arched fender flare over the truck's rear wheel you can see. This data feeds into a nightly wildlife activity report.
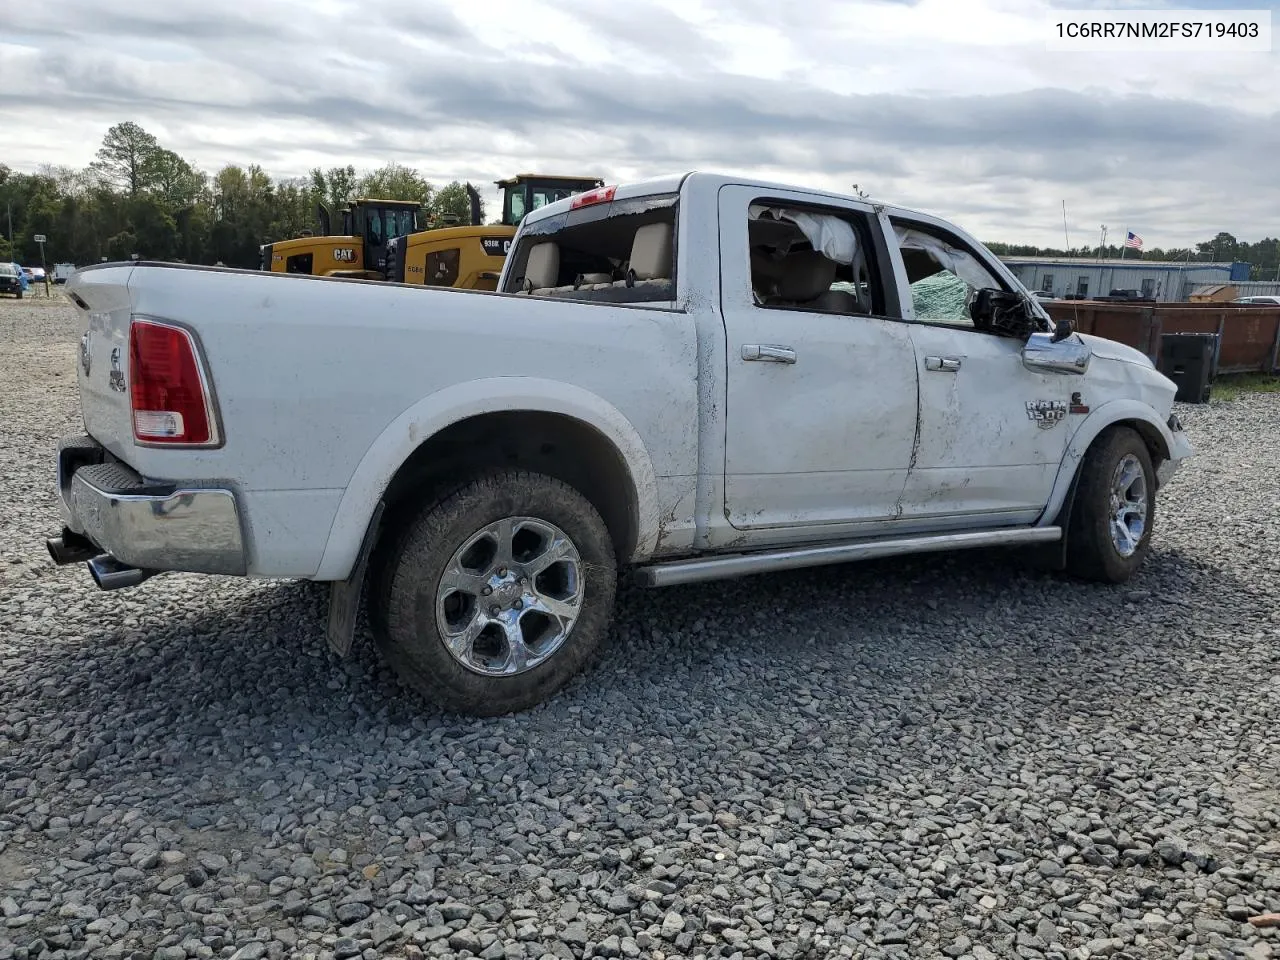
[312,376,659,580]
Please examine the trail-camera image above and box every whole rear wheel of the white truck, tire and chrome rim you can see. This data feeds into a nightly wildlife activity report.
[371,470,617,717]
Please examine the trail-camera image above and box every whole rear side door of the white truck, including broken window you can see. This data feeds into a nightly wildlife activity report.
[719,186,916,543]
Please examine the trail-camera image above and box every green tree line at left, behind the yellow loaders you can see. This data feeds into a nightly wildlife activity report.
[0,122,483,268]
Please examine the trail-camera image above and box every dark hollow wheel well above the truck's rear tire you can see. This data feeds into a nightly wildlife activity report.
[383,411,639,561]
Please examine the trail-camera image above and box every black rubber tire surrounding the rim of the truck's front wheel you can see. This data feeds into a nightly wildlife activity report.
[1066,426,1156,584]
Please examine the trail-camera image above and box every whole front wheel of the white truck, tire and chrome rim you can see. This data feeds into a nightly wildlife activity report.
[1066,426,1156,584]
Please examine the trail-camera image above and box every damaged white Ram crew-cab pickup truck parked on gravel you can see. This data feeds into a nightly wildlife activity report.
[49,173,1192,714]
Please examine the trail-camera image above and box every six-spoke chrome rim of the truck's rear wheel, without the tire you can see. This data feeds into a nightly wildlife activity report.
[435,517,584,677]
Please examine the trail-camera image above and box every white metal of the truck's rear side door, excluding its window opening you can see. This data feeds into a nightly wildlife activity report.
[719,186,916,541]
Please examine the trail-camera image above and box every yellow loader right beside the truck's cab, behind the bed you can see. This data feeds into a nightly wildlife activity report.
[385,173,604,291]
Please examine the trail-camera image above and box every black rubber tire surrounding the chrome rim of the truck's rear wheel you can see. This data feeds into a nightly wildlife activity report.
[370,470,617,717]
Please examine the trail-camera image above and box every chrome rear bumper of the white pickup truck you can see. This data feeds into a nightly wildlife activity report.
[58,436,248,576]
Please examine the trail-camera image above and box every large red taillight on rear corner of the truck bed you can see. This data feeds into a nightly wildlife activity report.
[129,320,219,445]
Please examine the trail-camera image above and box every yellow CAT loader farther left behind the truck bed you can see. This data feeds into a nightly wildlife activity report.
[259,197,422,280]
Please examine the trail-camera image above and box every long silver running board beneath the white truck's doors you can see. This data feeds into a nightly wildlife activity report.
[636,526,1062,586]
